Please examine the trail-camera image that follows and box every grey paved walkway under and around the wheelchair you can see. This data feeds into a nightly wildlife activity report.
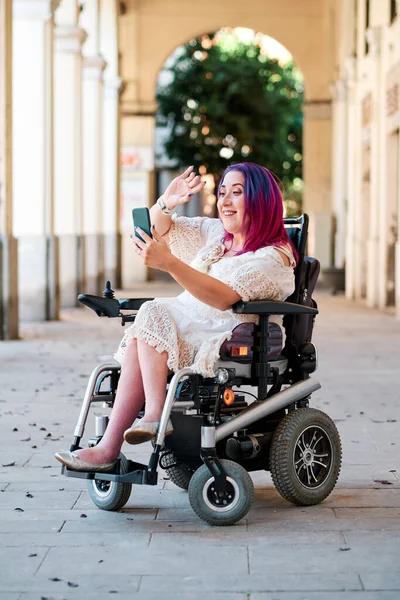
[0,286,400,600]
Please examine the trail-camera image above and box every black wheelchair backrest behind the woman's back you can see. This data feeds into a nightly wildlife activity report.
[283,214,320,353]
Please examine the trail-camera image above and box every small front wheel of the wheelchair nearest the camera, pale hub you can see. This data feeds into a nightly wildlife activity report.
[189,460,254,525]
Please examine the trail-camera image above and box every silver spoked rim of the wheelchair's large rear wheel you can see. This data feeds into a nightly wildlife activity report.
[293,425,333,489]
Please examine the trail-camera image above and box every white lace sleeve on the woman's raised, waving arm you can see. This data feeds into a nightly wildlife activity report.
[168,213,206,264]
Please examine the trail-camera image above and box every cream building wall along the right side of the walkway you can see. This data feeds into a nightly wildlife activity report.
[332,0,400,316]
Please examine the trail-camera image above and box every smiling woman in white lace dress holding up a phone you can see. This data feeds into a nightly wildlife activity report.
[56,163,295,471]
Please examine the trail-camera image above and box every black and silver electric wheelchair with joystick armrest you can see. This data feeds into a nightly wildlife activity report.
[62,214,341,525]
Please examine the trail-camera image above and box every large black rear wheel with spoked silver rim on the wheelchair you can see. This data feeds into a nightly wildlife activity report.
[269,408,342,506]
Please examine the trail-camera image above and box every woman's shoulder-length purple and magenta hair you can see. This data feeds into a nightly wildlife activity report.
[218,162,297,260]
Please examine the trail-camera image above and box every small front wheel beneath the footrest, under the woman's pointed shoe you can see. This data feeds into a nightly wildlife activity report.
[87,454,132,511]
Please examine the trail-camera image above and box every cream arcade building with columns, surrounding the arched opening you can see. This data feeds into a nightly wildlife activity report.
[0,0,400,338]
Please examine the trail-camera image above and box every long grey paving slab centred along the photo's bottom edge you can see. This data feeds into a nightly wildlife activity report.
[140,576,362,598]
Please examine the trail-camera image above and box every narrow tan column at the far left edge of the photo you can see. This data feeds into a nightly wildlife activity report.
[0,0,18,340]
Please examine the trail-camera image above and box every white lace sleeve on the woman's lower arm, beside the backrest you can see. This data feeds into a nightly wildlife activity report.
[224,248,294,302]
